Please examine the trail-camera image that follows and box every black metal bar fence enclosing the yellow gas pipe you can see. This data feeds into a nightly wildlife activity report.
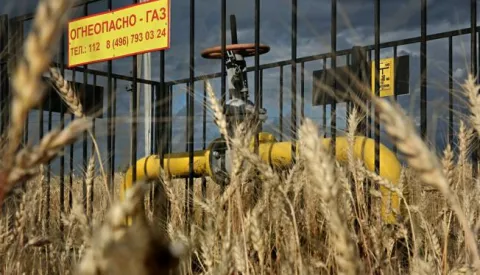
[0,0,478,227]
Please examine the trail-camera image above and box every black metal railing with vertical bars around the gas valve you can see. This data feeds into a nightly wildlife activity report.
[0,0,478,231]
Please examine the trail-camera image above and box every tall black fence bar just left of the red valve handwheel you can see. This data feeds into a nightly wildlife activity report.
[187,0,195,232]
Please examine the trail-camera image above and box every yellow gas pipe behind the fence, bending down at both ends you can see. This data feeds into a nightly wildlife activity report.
[120,133,401,224]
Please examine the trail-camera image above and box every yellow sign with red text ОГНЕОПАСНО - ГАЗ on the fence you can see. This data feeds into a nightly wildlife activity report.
[68,0,170,68]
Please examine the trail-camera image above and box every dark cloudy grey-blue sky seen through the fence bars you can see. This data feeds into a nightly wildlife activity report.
[0,0,480,177]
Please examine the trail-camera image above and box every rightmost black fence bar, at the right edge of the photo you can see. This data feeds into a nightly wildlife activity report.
[470,0,479,177]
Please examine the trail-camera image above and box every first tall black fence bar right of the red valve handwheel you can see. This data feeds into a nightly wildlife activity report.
[290,0,297,162]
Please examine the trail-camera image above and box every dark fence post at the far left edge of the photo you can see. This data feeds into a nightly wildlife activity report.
[0,15,10,134]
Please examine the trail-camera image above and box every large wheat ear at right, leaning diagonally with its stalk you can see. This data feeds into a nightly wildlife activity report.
[373,98,480,268]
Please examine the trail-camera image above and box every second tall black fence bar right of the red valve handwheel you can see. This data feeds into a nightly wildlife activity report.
[330,0,337,156]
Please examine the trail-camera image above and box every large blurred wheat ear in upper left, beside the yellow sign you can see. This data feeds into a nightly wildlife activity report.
[4,0,74,165]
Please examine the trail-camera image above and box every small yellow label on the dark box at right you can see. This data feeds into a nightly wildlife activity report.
[372,57,395,97]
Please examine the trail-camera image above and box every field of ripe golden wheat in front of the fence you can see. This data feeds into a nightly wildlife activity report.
[0,0,480,275]
